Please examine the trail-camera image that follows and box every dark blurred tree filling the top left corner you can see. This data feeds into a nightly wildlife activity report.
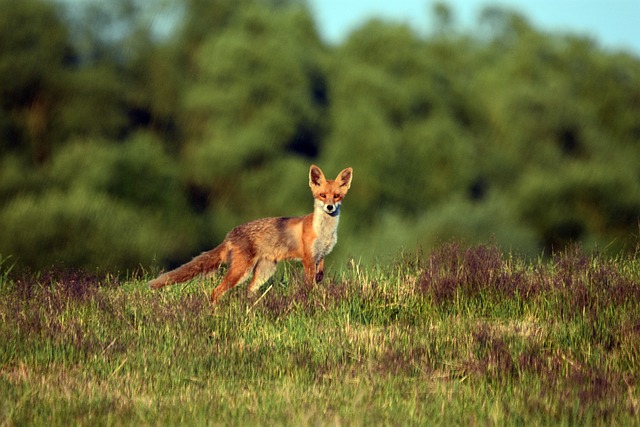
[0,0,72,163]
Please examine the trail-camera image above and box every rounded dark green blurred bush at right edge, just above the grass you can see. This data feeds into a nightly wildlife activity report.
[516,163,640,252]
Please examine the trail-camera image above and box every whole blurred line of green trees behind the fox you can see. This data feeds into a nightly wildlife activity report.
[0,0,640,271]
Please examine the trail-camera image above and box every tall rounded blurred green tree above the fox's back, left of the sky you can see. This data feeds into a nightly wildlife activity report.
[183,3,325,224]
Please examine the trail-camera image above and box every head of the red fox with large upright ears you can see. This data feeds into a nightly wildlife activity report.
[309,165,353,216]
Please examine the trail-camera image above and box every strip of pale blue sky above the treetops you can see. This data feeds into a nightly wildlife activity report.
[307,0,640,56]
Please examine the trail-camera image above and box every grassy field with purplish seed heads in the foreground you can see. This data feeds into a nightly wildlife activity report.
[0,244,640,426]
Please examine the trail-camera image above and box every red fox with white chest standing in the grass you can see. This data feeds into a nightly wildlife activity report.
[149,165,353,304]
